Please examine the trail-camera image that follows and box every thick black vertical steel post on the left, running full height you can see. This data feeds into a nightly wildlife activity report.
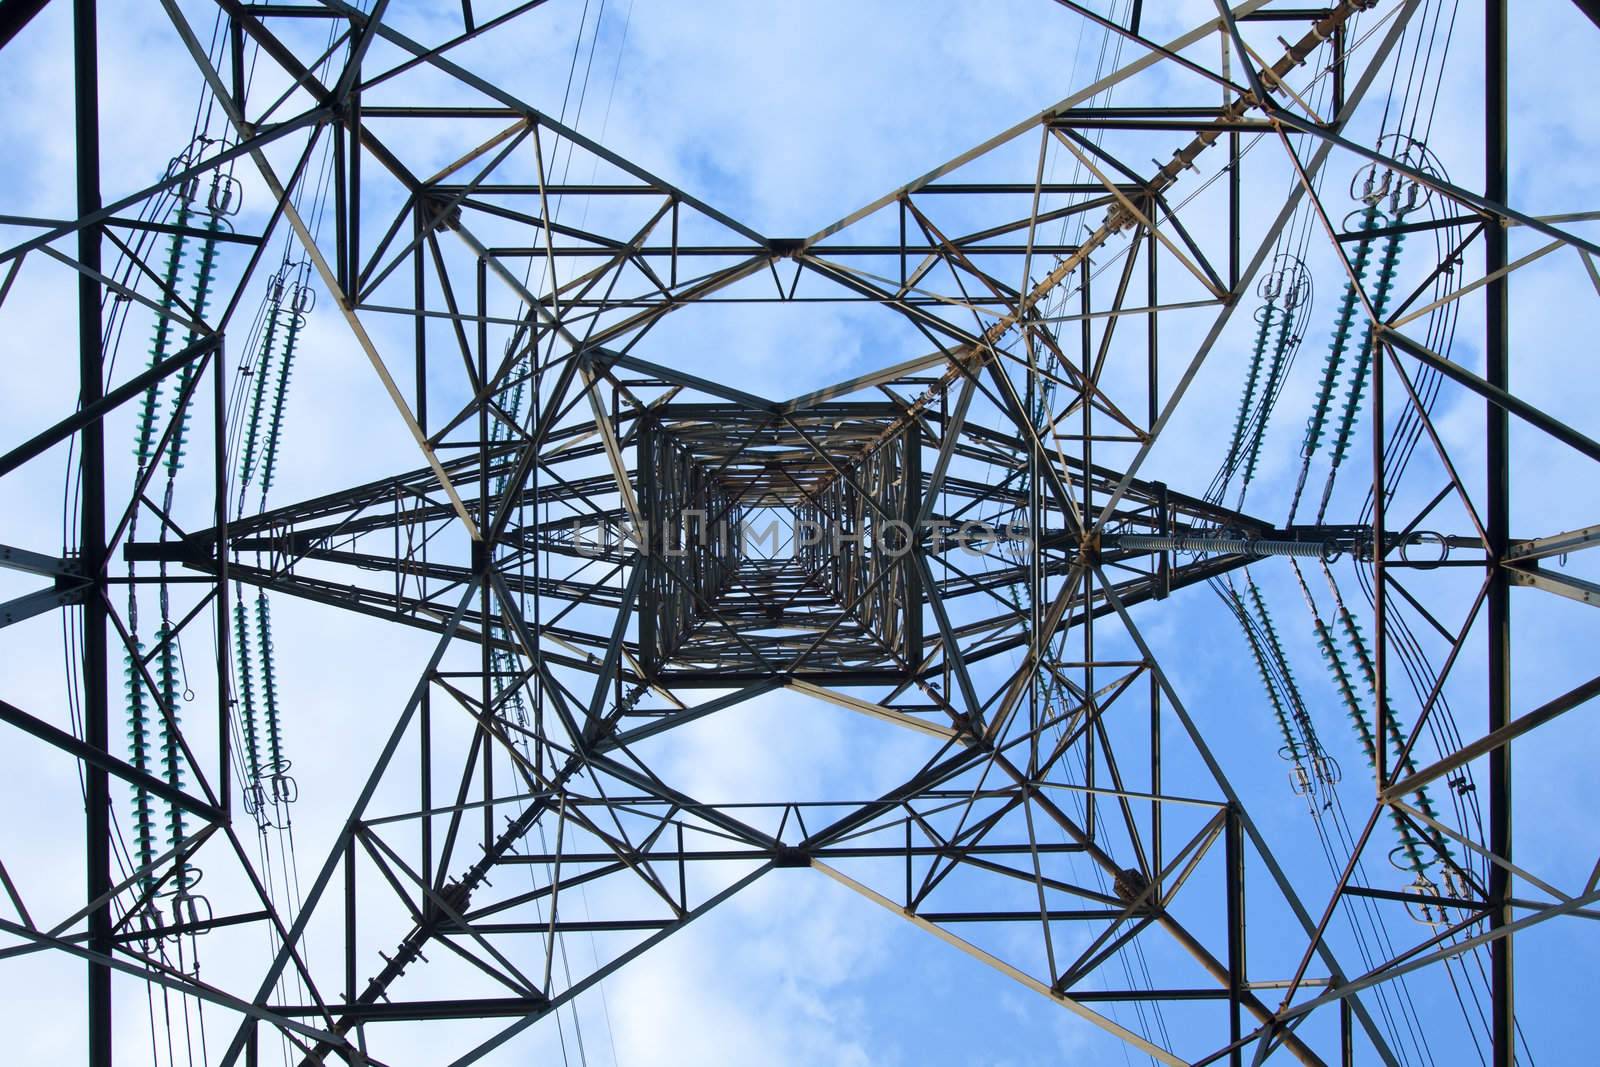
[72,0,112,1067]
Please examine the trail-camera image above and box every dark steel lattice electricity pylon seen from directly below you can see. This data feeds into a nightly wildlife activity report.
[0,0,1600,1067]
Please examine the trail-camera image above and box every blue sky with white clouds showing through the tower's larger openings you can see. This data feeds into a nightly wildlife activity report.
[0,0,1600,1064]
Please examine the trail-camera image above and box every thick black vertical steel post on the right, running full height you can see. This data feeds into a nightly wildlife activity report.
[1483,0,1515,1067]
